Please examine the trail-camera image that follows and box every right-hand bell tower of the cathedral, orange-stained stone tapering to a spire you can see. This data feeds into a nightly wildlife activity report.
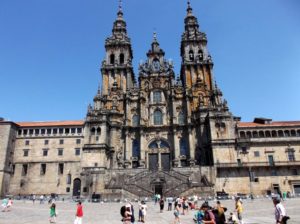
[180,1,214,111]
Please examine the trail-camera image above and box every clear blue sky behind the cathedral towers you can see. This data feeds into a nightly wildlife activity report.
[0,0,300,121]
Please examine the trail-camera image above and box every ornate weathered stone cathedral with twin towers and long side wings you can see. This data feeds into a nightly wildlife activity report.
[0,3,300,198]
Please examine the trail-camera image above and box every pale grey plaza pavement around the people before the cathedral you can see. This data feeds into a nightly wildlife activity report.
[0,198,300,224]
